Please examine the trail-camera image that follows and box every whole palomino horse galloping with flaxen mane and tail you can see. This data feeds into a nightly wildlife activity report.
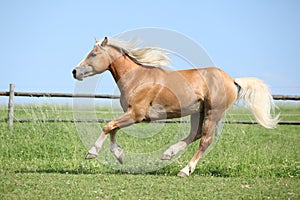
[72,37,279,177]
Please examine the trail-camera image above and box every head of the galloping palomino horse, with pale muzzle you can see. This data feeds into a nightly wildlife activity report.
[72,37,112,81]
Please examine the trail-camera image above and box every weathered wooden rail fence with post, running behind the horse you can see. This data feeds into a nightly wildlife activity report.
[0,84,300,130]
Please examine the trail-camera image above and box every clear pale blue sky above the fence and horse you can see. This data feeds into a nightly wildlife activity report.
[0,0,300,101]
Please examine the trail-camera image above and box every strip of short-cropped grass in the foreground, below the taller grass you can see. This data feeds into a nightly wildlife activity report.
[2,173,299,199]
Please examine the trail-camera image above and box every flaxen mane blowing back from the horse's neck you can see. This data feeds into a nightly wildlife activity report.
[108,38,170,67]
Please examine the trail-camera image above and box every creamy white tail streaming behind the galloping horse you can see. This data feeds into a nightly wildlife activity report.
[234,78,279,128]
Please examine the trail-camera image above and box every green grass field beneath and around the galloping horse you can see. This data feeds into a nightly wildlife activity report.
[0,104,300,199]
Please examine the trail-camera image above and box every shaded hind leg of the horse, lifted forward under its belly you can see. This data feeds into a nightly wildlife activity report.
[161,112,204,160]
